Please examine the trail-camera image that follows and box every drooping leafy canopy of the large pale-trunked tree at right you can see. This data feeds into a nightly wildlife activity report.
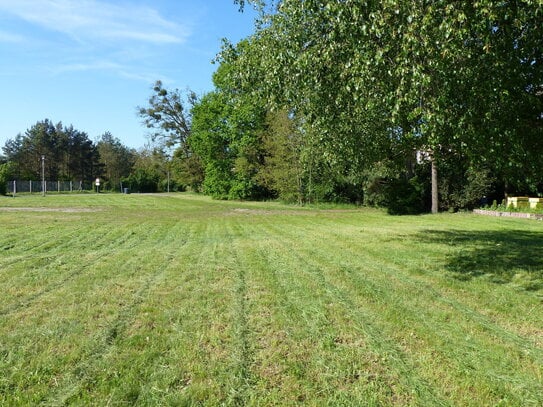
[226,0,543,212]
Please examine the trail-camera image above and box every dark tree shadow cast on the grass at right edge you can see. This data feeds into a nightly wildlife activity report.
[415,230,543,291]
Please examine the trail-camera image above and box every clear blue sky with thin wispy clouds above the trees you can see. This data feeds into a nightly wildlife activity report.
[0,0,260,150]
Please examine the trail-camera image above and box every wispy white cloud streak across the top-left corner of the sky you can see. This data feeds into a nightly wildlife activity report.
[0,0,190,44]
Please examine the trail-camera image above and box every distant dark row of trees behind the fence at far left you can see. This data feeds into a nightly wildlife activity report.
[0,119,177,193]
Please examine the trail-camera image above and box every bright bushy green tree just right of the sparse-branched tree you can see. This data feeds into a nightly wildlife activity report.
[189,58,270,199]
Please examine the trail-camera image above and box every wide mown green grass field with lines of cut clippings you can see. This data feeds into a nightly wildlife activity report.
[0,194,543,406]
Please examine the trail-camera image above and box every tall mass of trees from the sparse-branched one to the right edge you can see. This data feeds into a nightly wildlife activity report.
[2,0,543,213]
